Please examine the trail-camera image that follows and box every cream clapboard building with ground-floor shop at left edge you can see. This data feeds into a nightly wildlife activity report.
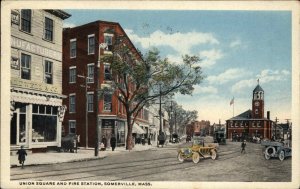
[10,9,71,149]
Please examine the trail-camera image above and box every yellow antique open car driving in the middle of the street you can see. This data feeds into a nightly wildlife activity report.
[177,137,217,163]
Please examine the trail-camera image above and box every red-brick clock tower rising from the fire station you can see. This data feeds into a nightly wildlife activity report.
[252,80,264,119]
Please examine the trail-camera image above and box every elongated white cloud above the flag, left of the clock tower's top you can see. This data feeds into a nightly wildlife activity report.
[207,68,250,84]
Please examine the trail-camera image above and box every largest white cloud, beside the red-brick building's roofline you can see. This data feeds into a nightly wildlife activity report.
[125,29,219,55]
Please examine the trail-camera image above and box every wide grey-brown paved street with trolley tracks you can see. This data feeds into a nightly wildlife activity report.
[11,142,291,182]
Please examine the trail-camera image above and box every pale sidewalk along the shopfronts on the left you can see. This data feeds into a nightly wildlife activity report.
[10,145,156,167]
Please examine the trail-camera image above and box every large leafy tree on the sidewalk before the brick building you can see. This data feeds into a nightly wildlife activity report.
[103,36,203,150]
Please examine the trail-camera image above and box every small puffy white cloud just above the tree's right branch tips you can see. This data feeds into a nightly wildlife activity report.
[199,49,224,68]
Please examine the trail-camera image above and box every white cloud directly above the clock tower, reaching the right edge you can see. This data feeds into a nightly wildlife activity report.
[231,69,290,93]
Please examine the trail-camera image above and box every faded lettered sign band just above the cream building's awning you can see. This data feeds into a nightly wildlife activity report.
[10,77,61,94]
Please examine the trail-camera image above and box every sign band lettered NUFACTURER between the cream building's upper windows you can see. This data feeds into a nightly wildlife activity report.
[11,37,62,61]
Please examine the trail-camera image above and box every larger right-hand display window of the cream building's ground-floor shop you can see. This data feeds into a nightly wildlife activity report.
[32,105,57,142]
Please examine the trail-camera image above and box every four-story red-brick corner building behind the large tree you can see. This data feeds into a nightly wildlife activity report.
[63,21,149,147]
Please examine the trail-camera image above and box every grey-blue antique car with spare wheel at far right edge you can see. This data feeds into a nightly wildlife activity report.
[261,140,292,161]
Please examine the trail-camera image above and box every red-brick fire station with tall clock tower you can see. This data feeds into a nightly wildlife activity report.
[226,84,273,140]
